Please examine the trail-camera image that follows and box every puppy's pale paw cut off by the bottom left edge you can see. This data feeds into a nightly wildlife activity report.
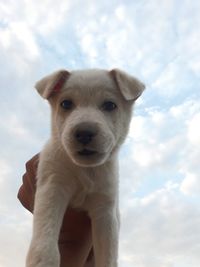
[26,245,60,267]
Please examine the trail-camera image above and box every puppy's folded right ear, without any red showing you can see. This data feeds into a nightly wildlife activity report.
[110,69,145,100]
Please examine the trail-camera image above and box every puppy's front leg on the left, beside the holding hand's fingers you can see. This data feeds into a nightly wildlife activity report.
[26,177,70,267]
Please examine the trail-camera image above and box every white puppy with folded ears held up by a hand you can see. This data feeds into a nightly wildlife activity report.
[26,69,145,267]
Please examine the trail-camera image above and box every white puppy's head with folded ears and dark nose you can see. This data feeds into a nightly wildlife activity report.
[36,69,145,167]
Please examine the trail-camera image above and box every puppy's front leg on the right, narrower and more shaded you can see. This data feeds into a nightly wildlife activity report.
[90,201,119,267]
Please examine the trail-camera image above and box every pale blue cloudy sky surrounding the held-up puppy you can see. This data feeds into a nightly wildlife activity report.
[0,0,200,267]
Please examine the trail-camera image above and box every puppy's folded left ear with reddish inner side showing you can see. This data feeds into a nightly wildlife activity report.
[35,70,70,99]
